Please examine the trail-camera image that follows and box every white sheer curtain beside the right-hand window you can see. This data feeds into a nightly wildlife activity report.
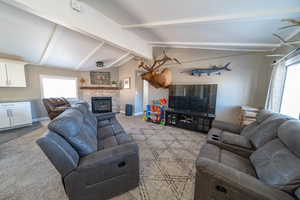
[265,62,287,112]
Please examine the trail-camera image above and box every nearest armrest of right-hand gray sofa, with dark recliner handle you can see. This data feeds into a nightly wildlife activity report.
[195,158,294,200]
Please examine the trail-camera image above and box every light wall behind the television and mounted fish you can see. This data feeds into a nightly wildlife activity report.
[149,49,271,123]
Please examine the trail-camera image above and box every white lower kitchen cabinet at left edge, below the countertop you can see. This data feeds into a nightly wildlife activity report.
[0,102,32,130]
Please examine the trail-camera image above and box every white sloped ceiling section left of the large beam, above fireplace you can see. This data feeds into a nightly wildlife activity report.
[0,2,131,70]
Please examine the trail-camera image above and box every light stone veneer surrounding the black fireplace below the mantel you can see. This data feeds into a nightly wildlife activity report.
[81,89,120,112]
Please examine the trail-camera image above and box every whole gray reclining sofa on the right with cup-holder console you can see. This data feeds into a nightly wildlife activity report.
[194,110,300,200]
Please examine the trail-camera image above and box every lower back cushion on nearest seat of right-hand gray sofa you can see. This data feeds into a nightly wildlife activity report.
[250,139,300,193]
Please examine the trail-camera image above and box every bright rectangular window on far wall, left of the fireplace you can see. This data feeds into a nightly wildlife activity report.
[40,75,78,98]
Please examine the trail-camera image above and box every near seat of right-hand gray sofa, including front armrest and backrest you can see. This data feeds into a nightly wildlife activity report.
[194,120,300,200]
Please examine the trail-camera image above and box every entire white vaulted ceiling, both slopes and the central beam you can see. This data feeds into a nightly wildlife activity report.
[0,0,300,70]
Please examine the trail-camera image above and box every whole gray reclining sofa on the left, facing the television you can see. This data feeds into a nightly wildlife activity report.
[37,103,139,200]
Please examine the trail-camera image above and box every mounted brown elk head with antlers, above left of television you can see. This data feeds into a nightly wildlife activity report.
[138,51,181,88]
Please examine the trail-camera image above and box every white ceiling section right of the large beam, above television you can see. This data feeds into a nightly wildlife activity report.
[81,0,300,51]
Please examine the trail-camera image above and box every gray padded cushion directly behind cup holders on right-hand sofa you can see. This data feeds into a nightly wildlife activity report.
[222,131,252,149]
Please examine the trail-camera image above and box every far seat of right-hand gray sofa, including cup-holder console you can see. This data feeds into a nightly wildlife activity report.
[207,110,291,156]
